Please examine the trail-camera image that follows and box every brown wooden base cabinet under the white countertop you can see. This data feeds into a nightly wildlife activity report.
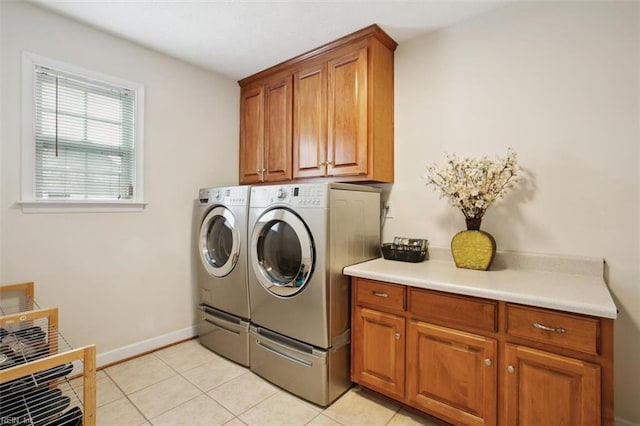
[351,278,614,426]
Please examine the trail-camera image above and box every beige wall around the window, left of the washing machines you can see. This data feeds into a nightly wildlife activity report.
[0,2,239,353]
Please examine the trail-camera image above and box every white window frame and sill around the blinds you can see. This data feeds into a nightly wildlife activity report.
[18,51,146,213]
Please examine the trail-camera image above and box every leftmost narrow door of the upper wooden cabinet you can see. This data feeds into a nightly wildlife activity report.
[240,86,264,184]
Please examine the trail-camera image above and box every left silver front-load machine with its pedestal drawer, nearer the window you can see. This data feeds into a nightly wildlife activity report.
[194,186,251,366]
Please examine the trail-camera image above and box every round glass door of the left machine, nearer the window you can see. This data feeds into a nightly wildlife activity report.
[198,206,240,278]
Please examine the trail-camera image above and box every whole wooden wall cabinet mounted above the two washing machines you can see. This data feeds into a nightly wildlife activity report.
[239,25,397,184]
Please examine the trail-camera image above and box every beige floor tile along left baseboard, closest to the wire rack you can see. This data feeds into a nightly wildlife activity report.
[105,354,176,395]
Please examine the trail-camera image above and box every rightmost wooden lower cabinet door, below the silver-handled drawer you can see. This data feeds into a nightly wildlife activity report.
[503,344,601,426]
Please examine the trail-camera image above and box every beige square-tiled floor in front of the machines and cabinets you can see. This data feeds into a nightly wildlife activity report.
[80,340,442,426]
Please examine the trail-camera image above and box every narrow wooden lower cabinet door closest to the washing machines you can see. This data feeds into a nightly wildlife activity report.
[351,307,405,398]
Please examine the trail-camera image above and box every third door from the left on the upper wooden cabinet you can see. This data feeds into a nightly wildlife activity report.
[293,63,327,178]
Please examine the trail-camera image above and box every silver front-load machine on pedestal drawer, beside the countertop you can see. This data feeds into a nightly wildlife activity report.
[248,183,381,406]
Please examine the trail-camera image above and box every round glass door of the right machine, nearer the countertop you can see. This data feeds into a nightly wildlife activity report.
[250,209,314,297]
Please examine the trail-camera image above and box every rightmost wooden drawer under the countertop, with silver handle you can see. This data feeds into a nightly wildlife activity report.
[506,304,600,354]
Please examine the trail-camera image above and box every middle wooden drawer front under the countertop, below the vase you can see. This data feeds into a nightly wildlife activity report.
[409,288,498,331]
